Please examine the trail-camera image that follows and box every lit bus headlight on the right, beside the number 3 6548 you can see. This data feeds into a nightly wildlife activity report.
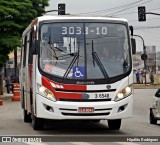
[114,86,133,101]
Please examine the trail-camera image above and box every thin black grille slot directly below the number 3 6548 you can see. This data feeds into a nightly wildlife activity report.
[59,98,111,102]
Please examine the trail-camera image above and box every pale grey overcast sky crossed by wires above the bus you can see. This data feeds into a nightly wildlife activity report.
[46,0,160,51]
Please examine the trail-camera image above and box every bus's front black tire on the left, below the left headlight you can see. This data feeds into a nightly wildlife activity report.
[32,115,44,130]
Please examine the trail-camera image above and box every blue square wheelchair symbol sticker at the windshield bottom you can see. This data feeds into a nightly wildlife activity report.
[73,66,85,79]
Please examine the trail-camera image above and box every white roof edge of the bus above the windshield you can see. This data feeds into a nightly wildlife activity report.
[23,15,127,36]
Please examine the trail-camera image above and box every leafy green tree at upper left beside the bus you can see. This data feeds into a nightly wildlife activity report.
[0,0,49,92]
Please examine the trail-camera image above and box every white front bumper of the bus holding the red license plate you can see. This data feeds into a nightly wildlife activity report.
[35,94,133,120]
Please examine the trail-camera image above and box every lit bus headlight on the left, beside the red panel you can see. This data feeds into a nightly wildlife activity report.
[37,84,56,101]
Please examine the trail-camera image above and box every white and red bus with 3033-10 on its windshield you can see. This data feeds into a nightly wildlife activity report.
[20,15,135,130]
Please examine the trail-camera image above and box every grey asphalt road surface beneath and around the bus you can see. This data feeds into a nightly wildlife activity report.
[0,89,160,145]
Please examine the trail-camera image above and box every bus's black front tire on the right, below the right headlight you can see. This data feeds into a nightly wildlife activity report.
[108,119,121,130]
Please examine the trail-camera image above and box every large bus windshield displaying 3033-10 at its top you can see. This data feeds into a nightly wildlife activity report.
[39,22,132,80]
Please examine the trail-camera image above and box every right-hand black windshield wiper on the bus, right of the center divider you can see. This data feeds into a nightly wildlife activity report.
[92,40,110,81]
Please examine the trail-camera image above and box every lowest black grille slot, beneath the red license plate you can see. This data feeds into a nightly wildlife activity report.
[62,112,110,116]
